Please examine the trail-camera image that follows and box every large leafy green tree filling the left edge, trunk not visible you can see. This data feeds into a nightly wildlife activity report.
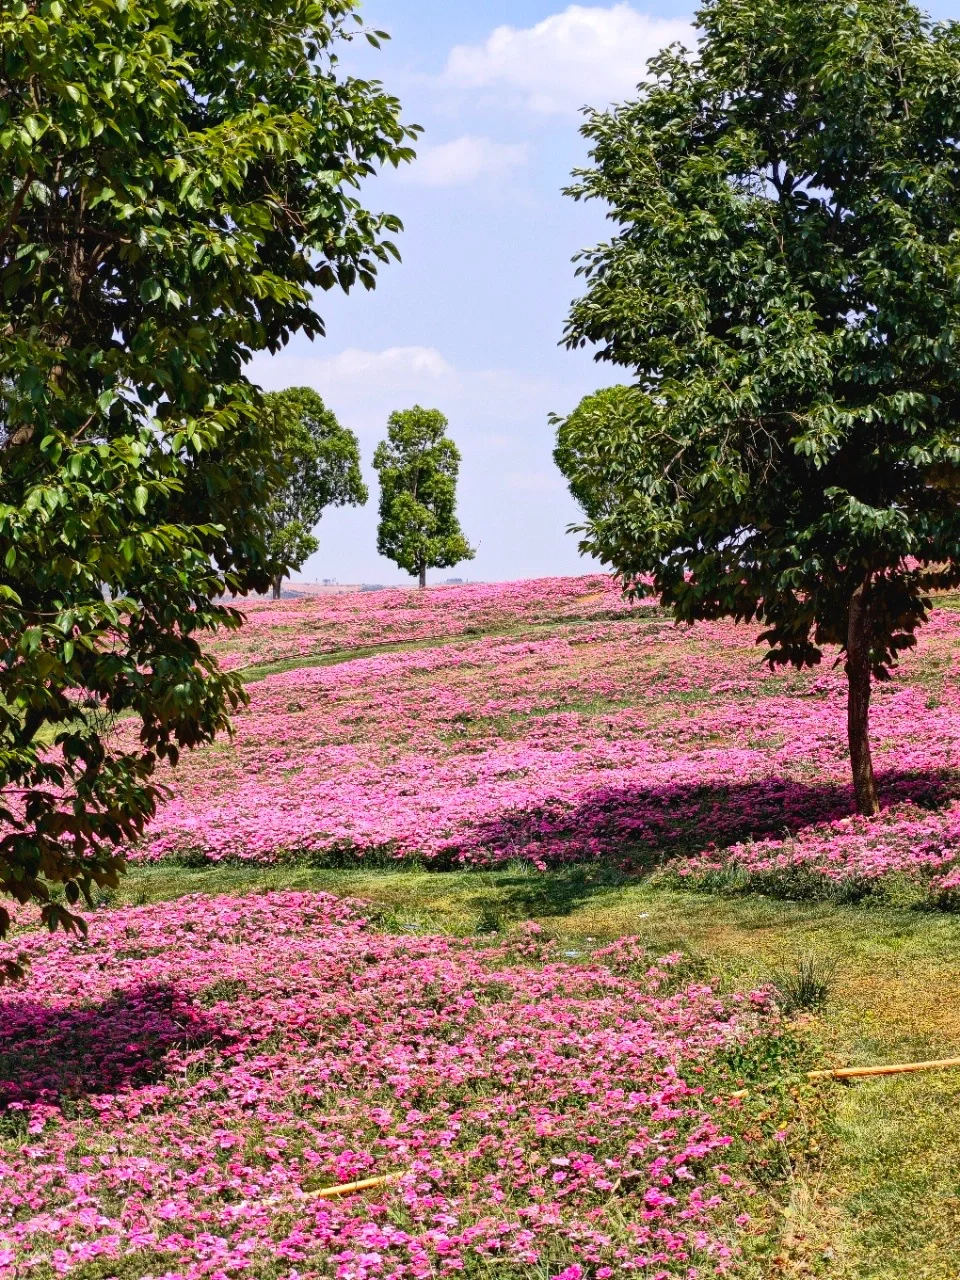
[0,0,413,962]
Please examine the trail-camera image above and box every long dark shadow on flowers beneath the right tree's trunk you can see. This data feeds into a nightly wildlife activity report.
[462,772,960,914]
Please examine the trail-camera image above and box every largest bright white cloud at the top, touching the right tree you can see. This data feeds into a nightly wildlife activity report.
[443,4,691,114]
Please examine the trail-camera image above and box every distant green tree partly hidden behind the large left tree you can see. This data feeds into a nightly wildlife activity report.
[264,387,369,600]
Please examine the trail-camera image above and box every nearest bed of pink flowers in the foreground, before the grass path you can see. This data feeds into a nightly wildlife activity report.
[0,893,788,1280]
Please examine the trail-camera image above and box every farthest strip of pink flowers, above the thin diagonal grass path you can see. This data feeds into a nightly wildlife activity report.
[206,573,649,668]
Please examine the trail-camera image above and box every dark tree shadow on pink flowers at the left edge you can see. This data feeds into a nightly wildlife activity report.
[0,986,219,1111]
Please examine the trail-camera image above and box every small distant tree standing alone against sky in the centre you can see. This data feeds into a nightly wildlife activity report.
[374,404,475,588]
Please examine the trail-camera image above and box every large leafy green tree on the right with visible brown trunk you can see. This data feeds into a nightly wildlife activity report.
[558,0,960,814]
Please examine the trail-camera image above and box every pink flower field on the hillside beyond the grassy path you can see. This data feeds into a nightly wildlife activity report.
[138,579,960,905]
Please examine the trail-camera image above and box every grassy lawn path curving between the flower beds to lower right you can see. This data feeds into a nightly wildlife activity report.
[118,864,960,1280]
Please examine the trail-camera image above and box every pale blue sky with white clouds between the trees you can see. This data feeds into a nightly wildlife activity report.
[251,0,960,585]
